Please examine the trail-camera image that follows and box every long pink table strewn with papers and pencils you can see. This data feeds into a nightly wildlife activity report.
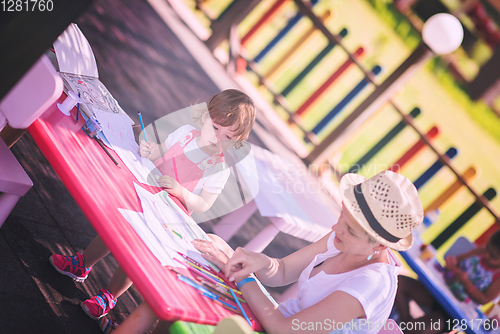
[28,94,262,330]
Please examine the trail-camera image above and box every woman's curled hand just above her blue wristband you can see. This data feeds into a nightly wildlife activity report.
[224,247,271,282]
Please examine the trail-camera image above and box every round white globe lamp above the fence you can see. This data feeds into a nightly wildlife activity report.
[422,13,464,54]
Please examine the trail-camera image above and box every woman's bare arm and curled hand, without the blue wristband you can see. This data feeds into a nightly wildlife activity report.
[224,232,331,286]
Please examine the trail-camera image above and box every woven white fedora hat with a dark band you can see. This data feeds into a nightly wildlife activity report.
[340,171,424,250]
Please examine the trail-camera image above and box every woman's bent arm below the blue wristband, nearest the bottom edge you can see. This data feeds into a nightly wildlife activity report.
[241,282,365,334]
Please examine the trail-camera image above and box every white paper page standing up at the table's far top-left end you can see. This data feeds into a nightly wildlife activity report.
[54,23,99,78]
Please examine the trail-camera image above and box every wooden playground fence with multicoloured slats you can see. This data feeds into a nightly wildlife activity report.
[176,0,500,254]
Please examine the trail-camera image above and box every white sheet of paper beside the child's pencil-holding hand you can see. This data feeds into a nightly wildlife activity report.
[94,109,161,186]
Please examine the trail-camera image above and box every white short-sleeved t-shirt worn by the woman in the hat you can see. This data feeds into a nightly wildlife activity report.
[278,232,401,334]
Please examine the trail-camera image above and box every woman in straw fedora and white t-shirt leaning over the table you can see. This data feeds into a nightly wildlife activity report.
[112,171,423,334]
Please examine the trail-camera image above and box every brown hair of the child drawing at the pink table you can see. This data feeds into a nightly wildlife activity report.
[193,89,255,148]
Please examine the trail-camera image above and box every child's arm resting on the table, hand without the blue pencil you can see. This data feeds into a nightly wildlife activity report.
[158,175,219,212]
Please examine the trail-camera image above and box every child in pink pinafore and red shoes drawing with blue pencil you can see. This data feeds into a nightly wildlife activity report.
[49,89,255,319]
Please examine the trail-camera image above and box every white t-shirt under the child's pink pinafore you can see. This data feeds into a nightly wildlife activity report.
[165,125,230,195]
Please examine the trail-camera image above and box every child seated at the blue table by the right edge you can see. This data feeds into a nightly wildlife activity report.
[395,231,500,334]
